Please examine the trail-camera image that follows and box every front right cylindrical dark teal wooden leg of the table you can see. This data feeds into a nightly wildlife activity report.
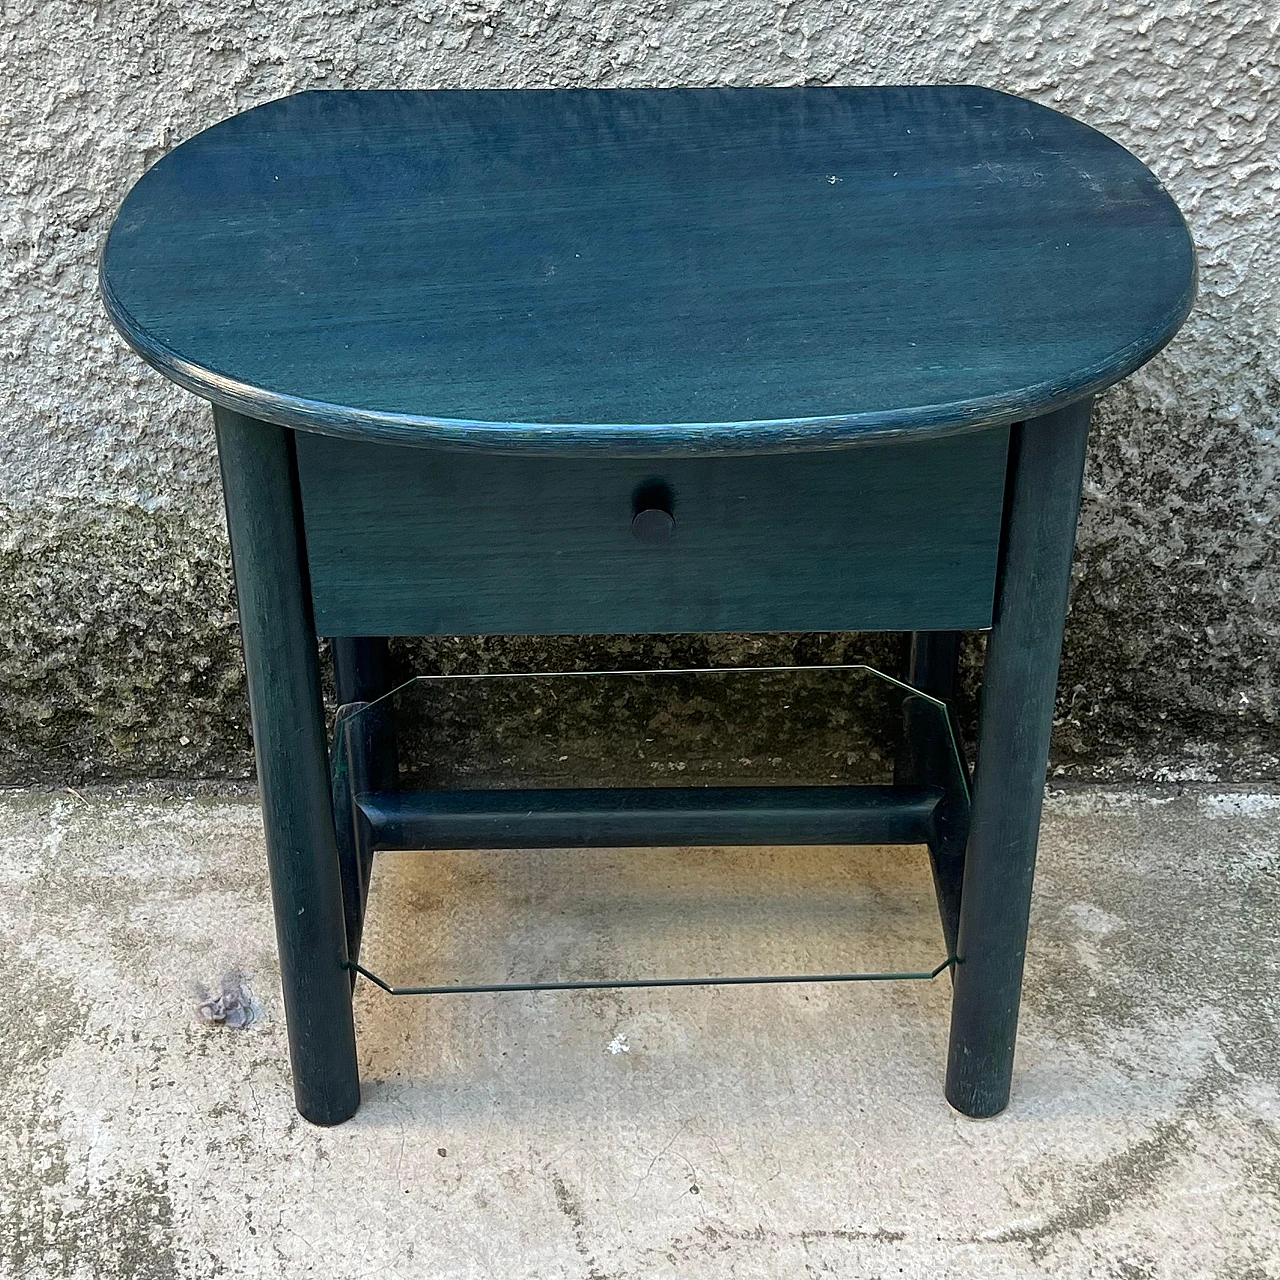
[947,401,1092,1116]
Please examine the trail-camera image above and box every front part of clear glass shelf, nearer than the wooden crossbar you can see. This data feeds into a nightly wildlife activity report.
[351,846,955,996]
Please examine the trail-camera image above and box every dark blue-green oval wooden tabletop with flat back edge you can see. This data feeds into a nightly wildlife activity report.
[101,87,1196,453]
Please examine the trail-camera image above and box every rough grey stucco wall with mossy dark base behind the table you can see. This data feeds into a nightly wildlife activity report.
[0,0,1280,781]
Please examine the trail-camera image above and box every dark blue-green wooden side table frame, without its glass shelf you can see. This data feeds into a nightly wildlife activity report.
[101,87,1196,1124]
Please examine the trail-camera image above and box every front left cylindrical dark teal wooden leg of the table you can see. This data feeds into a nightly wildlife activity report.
[214,408,360,1124]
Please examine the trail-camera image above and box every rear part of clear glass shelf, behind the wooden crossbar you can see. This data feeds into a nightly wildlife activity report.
[355,664,968,790]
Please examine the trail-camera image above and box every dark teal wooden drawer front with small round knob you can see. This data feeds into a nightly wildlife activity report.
[297,428,1009,636]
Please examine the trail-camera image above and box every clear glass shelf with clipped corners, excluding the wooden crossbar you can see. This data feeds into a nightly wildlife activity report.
[339,666,968,995]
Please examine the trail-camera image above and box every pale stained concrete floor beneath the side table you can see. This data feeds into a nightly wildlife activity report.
[0,788,1280,1280]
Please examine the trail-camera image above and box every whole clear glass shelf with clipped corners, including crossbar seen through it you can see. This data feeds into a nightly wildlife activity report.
[332,666,969,995]
